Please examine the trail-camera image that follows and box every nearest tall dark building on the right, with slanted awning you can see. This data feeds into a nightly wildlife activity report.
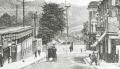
[87,0,120,62]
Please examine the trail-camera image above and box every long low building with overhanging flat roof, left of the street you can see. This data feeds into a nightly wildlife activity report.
[0,26,33,63]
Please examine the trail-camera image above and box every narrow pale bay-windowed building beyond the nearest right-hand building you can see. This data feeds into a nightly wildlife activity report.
[88,1,99,50]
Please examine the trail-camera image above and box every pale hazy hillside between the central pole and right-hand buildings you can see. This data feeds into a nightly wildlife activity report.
[64,5,89,34]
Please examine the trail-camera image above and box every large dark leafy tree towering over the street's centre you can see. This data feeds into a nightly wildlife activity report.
[38,3,65,44]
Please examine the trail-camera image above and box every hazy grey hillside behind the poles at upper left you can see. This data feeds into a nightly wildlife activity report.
[0,0,45,26]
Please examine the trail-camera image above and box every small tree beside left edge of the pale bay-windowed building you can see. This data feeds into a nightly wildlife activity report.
[81,22,89,44]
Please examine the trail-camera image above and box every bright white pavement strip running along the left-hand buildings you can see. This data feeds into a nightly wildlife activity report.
[0,52,46,69]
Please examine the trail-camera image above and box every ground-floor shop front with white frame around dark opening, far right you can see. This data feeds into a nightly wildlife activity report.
[105,35,120,63]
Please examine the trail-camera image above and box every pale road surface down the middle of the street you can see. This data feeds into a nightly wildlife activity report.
[24,44,94,69]
